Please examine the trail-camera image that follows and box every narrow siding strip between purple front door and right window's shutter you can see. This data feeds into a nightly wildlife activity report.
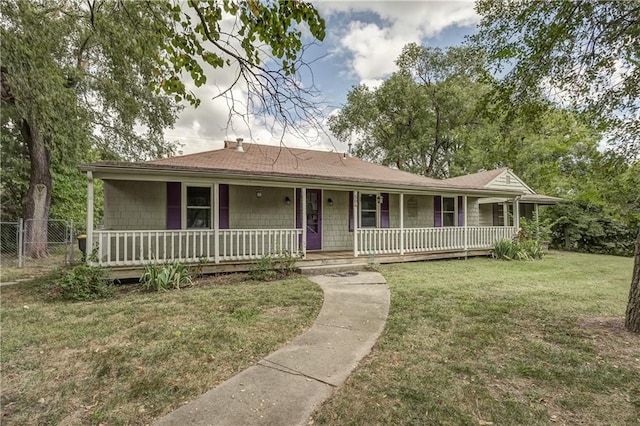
[322,191,353,250]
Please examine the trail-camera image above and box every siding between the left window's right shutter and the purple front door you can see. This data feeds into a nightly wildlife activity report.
[229,185,296,229]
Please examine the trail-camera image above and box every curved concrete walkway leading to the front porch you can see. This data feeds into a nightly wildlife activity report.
[155,272,389,426]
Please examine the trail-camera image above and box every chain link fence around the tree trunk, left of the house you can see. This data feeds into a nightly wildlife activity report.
[0,219,82,268]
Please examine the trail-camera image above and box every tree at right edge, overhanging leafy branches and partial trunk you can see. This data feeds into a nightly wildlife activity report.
[475,0,640,333]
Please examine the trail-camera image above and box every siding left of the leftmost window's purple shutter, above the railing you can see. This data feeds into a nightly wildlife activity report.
[104,180,167,230]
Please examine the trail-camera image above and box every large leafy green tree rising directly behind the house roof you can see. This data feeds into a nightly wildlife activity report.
[329,44,486,177]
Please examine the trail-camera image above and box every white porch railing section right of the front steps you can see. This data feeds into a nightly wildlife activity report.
[356,226,516,255]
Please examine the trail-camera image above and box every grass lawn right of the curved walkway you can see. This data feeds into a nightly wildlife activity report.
[314,252,640,425]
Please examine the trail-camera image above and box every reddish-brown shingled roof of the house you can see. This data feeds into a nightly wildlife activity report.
[80,142,552,195]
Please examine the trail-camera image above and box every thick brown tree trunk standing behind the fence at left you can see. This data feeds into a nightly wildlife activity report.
[20,119,51,259]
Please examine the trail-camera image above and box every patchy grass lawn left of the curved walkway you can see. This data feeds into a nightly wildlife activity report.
[1,278,322,425]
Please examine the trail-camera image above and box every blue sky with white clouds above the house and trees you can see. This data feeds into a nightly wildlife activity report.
[165,0,479,154]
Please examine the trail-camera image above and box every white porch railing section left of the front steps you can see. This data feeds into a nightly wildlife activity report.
[93,229,302,266]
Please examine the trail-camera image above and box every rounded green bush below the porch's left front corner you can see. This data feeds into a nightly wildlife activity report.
[51,263,116,301]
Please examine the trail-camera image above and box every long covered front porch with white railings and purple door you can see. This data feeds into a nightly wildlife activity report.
[87,171,517,271]
